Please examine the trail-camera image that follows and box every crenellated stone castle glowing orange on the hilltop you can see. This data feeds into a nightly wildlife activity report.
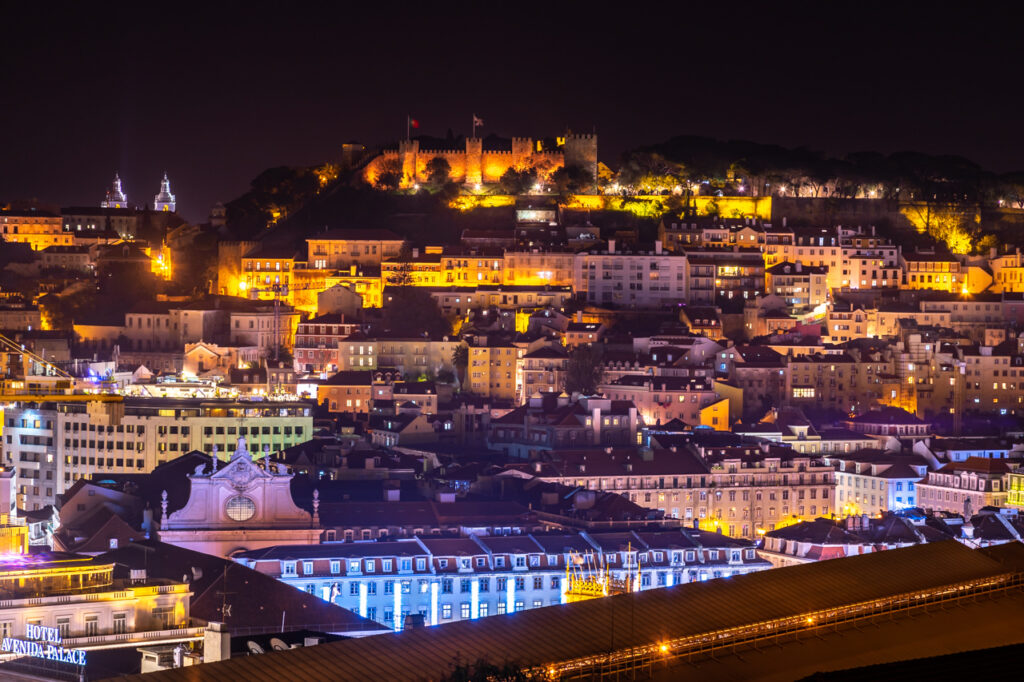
[365,135,597,186]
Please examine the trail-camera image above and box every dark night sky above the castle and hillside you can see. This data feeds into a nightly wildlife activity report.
[0,2,1024,220]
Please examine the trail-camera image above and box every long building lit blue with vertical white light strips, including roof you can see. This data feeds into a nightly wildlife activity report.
[234,530,770,630]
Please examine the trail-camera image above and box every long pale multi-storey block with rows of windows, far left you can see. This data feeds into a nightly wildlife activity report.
[3,397,312,510]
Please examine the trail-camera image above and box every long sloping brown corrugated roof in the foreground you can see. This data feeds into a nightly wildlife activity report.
[105,542,1013,682]
